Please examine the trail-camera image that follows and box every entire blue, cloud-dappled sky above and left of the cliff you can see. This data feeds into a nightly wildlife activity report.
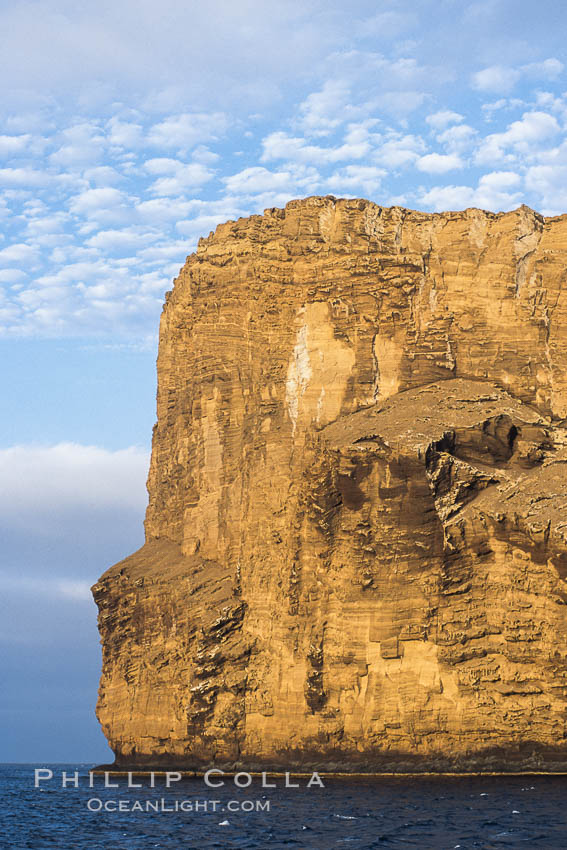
[0,0,567,763]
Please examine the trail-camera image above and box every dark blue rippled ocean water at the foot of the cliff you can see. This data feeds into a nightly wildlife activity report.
[0,765,567,850]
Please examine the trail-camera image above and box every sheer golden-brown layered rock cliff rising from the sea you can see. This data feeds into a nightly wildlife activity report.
[93,198,567,770]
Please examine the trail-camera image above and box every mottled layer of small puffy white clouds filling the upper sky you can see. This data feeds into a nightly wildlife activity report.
[0,0,567,340]
